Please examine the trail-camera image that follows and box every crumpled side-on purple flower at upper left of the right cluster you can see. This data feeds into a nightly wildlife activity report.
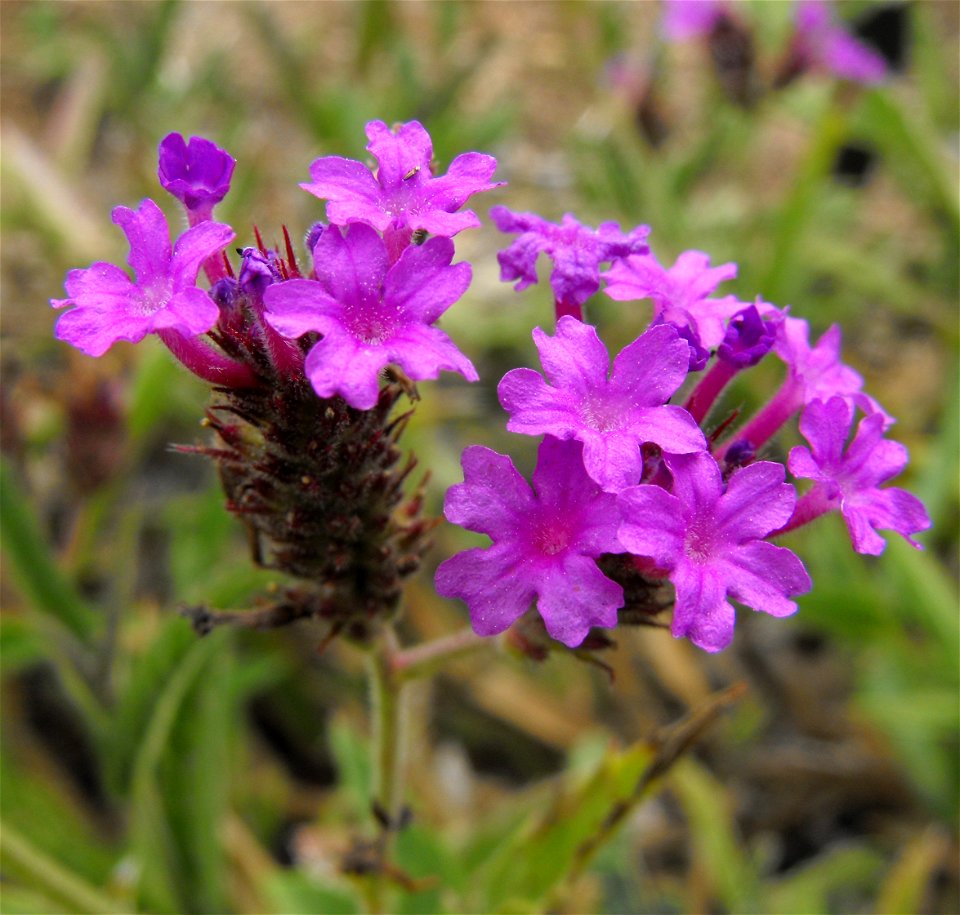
[490,206,650,317]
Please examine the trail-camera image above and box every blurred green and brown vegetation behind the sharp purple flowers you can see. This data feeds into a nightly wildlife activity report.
[0,0,960,913]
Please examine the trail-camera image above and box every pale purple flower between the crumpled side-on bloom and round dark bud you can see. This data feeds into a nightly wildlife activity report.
[603,251,748,349]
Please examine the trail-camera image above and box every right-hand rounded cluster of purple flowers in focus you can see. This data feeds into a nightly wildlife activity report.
[436,207,930,651]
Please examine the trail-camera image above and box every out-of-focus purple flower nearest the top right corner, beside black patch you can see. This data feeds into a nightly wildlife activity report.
[791,0,887,83]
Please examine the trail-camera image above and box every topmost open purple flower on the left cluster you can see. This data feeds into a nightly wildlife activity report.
[300,121,502,251]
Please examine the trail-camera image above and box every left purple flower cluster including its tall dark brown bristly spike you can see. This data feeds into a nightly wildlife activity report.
[51,121,498,638]
